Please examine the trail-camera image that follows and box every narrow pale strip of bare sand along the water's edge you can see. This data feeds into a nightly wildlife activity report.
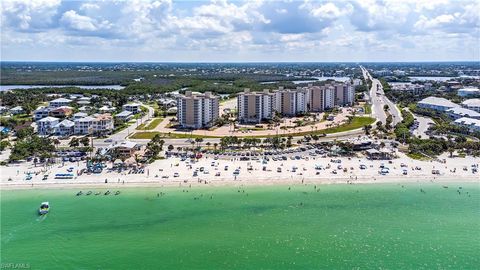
[0,176,480,191]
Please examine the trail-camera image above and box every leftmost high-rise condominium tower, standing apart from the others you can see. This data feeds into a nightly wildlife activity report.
[177,91,219,128]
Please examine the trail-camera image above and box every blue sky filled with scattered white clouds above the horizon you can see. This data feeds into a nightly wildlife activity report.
[0,0,480,62]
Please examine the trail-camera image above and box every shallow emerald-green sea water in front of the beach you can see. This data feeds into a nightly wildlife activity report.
[1,184,480,269]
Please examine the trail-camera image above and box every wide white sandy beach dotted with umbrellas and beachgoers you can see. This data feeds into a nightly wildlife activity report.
[0,154,480,190]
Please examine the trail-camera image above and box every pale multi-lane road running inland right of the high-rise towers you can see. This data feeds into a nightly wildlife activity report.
[360,66,403,126]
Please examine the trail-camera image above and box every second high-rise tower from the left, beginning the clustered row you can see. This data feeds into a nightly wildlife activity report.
[237,88,275,123]
